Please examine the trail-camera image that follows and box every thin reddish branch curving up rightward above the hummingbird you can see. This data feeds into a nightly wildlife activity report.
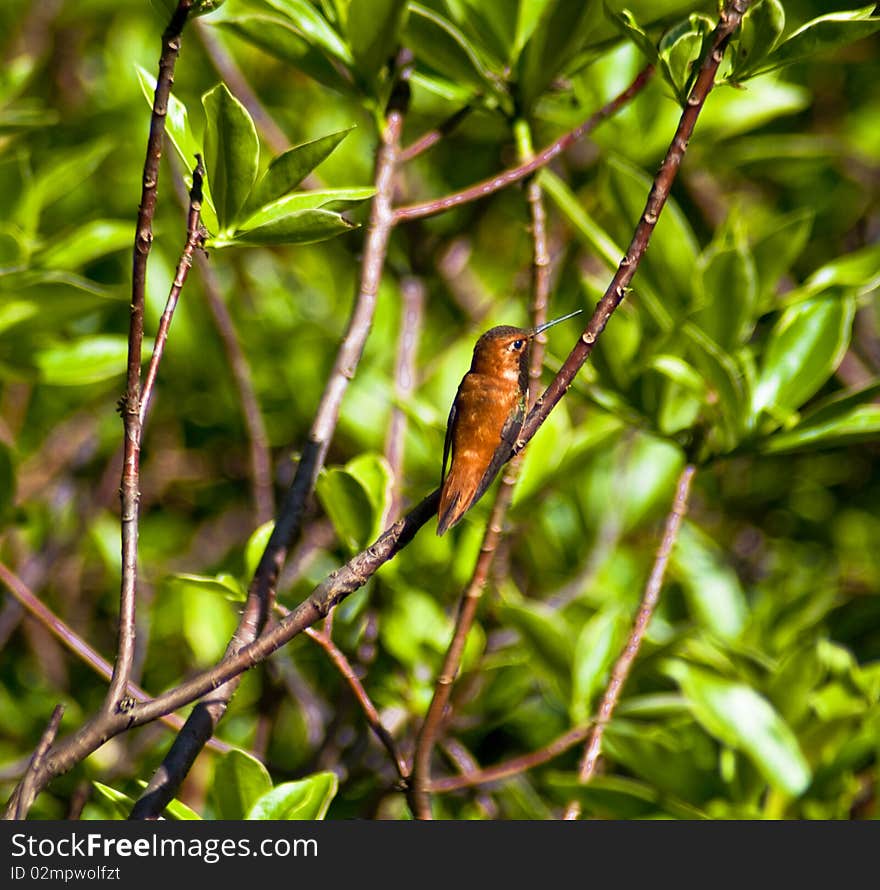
[394,65,654,225]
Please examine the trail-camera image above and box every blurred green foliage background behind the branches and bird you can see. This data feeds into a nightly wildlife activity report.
[0,0,880,819]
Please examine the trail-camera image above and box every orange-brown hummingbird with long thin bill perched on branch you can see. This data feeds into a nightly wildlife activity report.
[437,309,581,535]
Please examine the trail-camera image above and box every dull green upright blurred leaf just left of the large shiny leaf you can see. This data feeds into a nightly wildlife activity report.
[693,244,758,350]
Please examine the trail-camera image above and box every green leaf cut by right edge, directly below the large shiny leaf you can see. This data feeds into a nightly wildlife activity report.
[761,382,880,454]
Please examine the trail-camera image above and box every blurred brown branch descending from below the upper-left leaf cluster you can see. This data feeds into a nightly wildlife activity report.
[196,253,275,525]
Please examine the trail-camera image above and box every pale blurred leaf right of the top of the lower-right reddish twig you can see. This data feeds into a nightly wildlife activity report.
[672,521,748,639]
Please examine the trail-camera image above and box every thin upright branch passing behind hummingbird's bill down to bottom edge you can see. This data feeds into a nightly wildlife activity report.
[409,121,550,819]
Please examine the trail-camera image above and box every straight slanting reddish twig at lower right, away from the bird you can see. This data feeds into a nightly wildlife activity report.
[564,464,696,820]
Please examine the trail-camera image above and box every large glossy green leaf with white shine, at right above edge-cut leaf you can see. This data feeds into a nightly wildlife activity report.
[752,294,855,419]
